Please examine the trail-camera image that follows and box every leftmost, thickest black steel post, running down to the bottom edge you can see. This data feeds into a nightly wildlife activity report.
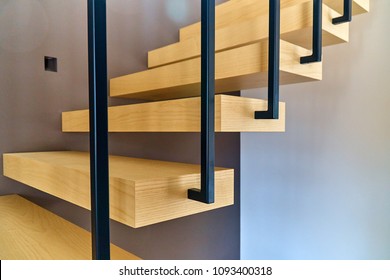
[88,0,110,260]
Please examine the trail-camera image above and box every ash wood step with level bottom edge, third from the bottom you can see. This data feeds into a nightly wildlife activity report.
[62,95,285,132]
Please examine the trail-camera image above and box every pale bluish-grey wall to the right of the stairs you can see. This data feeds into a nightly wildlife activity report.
[241,0,390,259]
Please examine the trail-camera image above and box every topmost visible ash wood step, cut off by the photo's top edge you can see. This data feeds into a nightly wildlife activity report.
[179,0,370,41]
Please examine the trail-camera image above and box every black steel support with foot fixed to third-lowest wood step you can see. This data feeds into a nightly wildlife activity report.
[255,0,280,119]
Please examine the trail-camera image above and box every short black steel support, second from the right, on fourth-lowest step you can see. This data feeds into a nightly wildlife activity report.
[301,0,322,64]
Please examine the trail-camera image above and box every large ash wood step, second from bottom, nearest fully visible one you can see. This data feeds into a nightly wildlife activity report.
[3,152,234,228]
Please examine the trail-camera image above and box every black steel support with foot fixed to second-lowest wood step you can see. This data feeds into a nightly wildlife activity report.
[188,0,215,204]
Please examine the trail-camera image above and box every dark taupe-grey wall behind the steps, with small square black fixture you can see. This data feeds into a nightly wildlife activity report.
[0,0,240,259]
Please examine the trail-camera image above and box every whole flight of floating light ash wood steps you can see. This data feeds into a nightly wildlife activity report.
[0,0,369,259]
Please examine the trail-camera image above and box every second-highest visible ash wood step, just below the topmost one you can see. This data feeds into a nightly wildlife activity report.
[148,1,349,68]
